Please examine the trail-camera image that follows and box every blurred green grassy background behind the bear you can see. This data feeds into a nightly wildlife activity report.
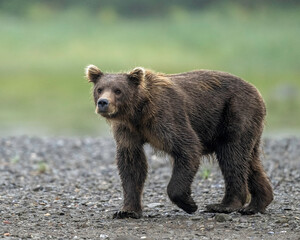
[0,0,300,136]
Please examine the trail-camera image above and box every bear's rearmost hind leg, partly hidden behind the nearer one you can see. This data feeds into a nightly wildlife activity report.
[240,141,273,214]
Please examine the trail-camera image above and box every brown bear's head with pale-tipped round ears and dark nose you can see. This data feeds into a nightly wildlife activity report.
[86,65,145,120]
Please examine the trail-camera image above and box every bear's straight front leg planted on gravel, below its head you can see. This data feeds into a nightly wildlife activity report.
[113,142,148,218]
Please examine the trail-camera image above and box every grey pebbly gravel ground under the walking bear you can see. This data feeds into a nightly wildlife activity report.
[0,136,300,239]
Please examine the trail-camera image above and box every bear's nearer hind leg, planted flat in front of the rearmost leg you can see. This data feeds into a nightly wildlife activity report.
[206,143,250,213]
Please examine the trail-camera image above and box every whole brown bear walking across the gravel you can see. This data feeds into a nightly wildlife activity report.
[86,65,273,218]
